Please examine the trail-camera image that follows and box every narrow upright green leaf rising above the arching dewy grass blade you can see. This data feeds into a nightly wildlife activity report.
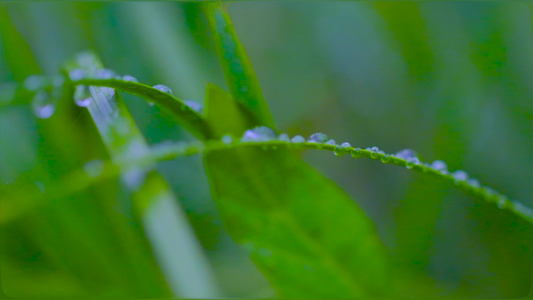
[205,3,274,128]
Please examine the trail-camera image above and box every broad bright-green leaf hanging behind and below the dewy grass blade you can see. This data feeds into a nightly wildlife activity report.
[204,85,388,297]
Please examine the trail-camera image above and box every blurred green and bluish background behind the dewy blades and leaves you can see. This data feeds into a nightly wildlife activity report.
[0,1,533,299]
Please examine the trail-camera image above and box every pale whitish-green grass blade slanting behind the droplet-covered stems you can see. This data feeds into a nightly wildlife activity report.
[67,53,217,297]
